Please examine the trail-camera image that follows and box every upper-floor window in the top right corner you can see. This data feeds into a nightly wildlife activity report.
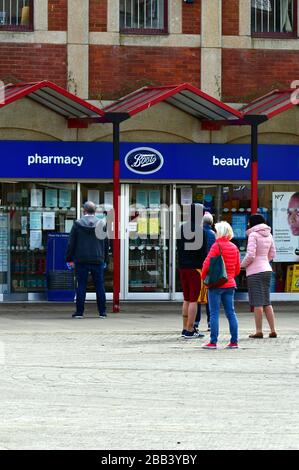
[251,0,298,37]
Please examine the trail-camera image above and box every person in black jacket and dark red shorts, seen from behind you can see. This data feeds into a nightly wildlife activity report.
[177,204,208,339]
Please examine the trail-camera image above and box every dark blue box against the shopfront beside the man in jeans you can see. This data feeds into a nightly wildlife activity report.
[46,233,75,302]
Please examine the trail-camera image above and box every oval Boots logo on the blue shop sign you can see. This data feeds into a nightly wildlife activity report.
[125,147,164,175]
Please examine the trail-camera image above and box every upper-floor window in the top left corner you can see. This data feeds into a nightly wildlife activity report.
[0,0,33,31]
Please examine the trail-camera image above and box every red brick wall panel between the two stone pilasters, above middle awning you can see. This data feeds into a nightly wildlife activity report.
[89,45,200,99]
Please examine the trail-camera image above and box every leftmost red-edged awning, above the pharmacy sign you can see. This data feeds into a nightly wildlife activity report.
[0,80,104,119]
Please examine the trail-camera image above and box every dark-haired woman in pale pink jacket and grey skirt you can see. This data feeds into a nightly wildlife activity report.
[241,214,277,338]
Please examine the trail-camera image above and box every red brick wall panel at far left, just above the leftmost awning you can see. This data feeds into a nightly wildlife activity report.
[0,43,67,88]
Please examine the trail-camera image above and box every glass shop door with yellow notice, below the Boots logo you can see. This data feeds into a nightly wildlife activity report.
[124,184,172,300]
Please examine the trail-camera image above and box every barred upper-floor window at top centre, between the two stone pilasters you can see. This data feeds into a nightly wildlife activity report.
[119,0,167,34]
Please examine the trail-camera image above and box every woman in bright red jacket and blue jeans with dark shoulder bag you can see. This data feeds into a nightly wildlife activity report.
[202,222,240,349]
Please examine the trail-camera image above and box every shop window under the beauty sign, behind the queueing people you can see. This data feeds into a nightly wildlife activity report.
[176,182,299,293]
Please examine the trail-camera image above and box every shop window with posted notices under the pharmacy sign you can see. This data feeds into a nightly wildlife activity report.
[0,182,76,294]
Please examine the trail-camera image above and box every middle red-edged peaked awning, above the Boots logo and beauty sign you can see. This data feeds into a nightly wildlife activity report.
[103,83,243,121]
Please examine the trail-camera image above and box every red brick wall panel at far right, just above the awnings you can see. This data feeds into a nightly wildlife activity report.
[222,49,299,102]
